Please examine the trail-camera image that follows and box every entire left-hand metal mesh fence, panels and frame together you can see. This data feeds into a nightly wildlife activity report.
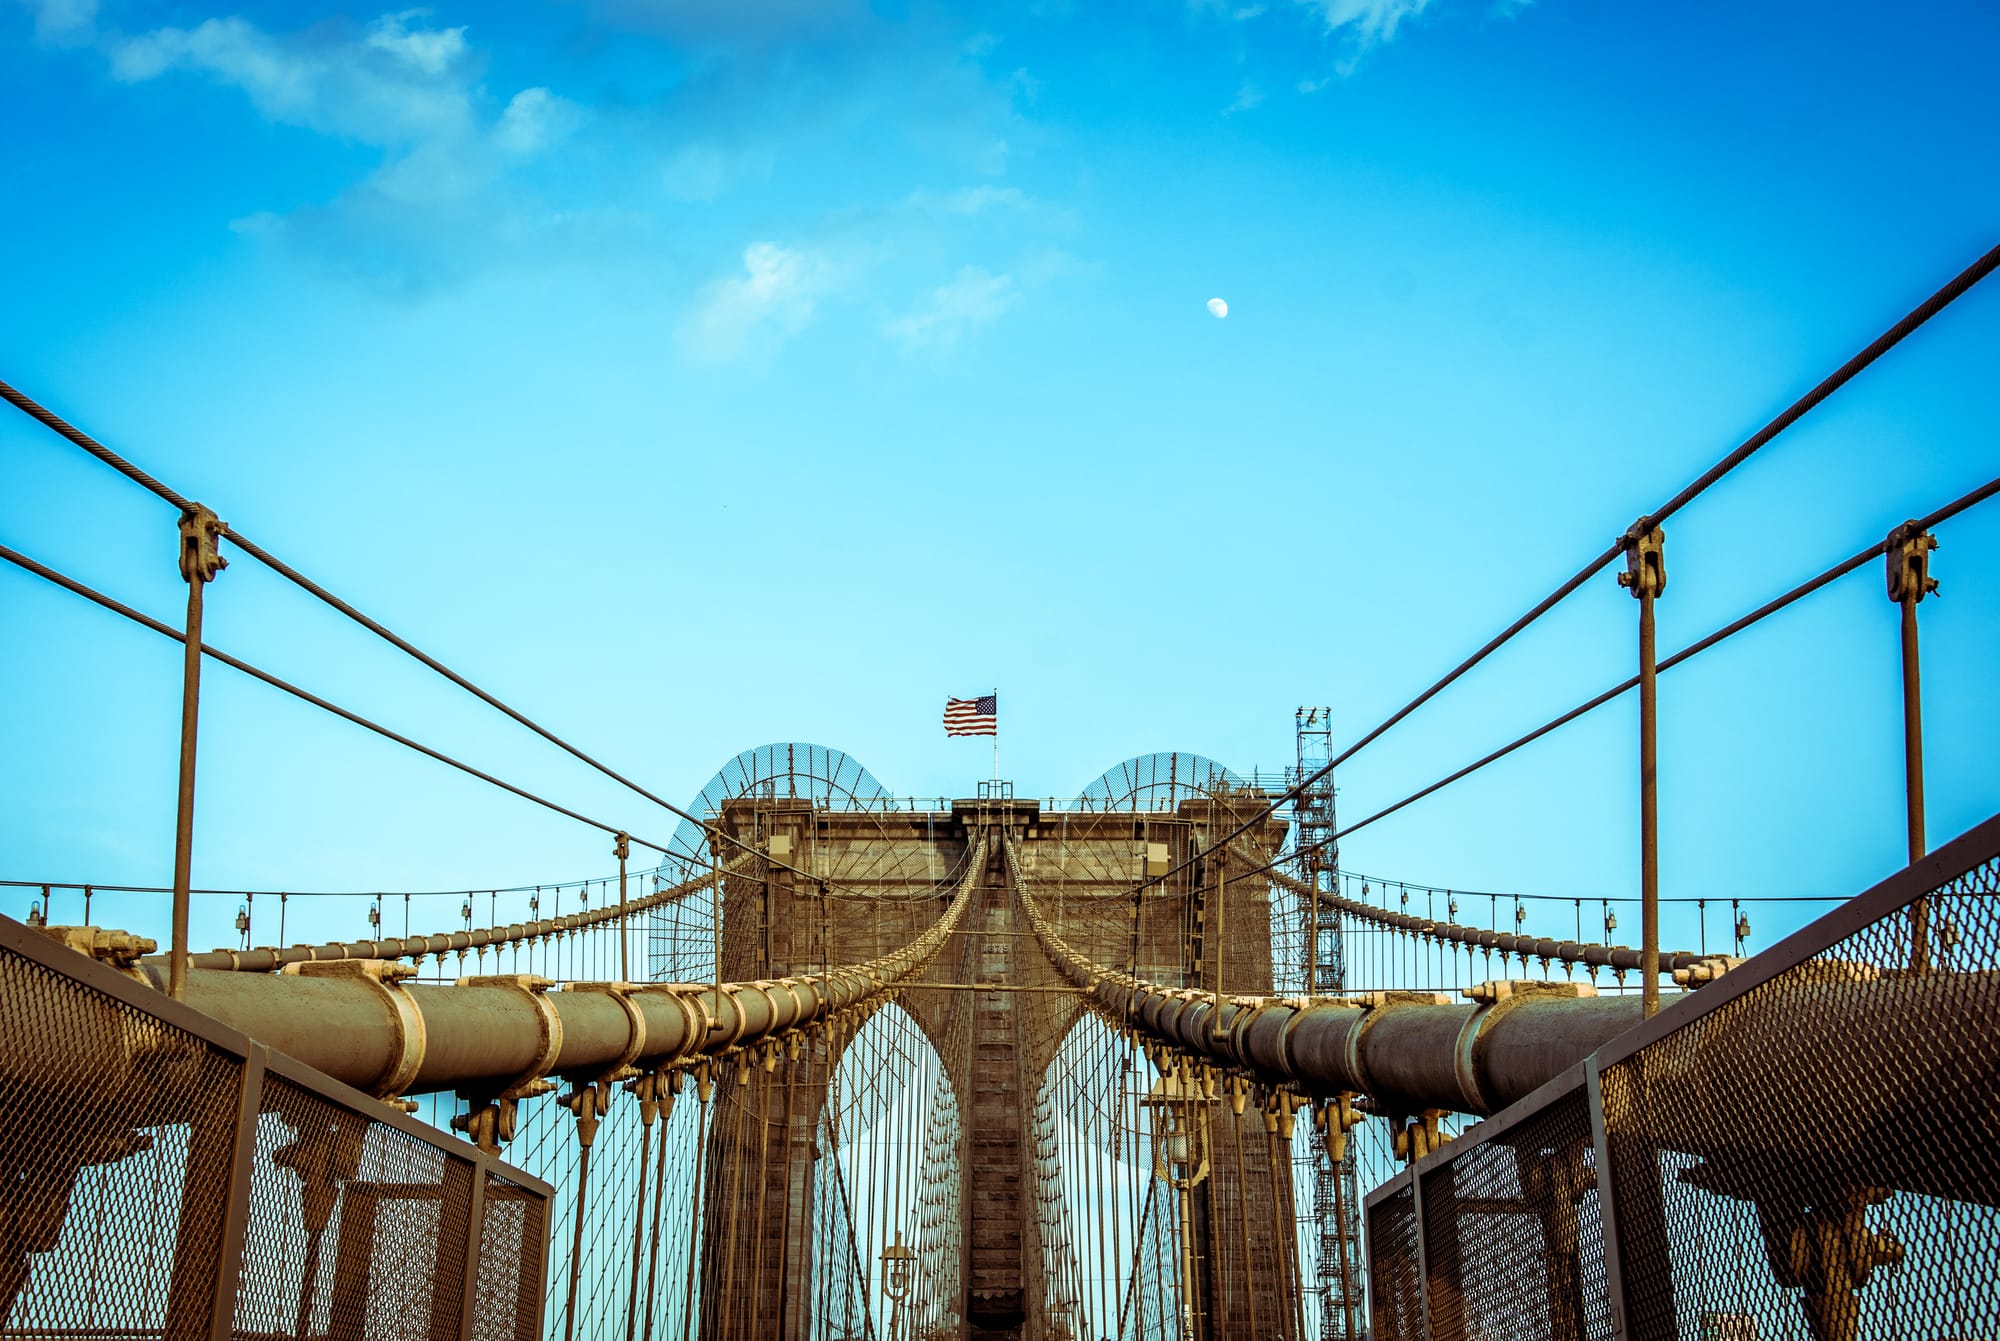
[0,919,550,1341]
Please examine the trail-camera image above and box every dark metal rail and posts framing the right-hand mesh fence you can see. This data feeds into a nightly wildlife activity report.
[1362,815,2000,1341]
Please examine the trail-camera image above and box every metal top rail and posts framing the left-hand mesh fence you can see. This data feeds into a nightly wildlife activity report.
[0,915,554,1341]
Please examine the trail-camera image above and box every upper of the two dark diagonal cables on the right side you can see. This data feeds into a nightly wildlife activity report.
[1134,246,2000,891]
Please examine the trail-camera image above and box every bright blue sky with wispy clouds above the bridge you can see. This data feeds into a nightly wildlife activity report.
[0,0,2000,956]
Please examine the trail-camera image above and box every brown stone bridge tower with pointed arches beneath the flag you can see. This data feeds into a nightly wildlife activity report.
[702,787,1294,1341]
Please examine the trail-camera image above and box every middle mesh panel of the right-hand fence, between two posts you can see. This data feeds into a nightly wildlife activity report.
[1422,1089,1612,1341]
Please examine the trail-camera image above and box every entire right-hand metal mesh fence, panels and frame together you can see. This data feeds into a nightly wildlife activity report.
[1368,817,2000,1341]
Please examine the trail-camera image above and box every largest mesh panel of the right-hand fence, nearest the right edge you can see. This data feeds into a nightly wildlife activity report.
[1602,861,2000,1341]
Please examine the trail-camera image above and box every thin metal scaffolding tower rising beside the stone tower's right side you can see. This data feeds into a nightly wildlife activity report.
[1292,707,1366,1341]
